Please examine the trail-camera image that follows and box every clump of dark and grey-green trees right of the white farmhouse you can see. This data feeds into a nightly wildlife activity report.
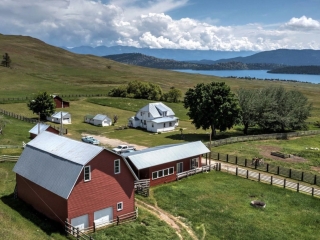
[184,82,312,136]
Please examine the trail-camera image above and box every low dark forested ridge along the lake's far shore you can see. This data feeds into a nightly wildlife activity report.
[104,53,284,70]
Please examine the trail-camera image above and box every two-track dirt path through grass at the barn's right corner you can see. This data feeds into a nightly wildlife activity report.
[136,199,198,240]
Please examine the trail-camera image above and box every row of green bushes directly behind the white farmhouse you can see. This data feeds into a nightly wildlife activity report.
[108,80,182,102]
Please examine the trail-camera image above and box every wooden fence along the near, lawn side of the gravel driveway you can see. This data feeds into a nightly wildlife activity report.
[218,166,320,197]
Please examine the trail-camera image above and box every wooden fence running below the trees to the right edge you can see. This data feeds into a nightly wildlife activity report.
[207,130,320,147]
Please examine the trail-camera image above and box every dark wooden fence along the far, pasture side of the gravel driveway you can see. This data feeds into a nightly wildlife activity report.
[211,152,320,186]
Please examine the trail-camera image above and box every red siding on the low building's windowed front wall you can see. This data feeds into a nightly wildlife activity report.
[144,156,201,186]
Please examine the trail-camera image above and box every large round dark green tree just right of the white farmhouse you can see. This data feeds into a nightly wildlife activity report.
[184,82,240,136]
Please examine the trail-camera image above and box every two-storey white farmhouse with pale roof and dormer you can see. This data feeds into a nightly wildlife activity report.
[128,102,179,132]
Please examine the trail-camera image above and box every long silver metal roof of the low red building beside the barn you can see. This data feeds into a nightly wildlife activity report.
[123,141,210,170]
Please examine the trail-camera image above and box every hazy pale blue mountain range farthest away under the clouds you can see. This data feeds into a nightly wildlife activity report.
[62,46,256,61]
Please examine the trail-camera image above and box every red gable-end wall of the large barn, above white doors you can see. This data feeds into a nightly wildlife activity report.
[68,150,135,226]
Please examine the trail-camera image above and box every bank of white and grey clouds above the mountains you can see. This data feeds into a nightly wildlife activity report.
[0,0,320,51]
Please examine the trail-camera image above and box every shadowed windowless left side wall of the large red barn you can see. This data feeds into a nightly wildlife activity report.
[16,174,67,225]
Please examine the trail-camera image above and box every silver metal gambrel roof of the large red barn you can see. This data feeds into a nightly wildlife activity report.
[13,131,104,199]
